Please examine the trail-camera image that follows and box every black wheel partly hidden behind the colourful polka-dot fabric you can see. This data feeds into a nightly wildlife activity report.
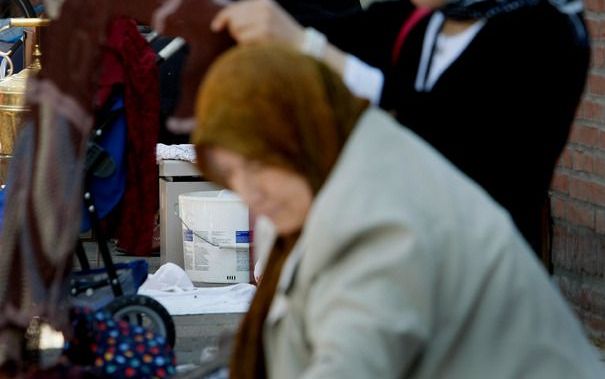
[105,295,176,347]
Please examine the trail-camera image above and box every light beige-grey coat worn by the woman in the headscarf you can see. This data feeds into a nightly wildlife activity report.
[264,110,604,379]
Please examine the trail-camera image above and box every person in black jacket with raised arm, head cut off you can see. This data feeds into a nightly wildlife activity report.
[213,0,590,253]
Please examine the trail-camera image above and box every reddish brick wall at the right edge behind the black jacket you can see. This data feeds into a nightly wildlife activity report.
[551,0,605,347]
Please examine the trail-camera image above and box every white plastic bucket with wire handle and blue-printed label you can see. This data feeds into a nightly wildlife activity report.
[179,190,250,283]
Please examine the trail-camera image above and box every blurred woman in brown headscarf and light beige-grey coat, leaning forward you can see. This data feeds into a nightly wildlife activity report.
[193,46,602,379]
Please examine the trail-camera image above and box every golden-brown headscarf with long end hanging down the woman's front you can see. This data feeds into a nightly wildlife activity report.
[192,45,368,379]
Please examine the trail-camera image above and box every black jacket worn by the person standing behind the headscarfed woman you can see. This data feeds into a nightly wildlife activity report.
[314,1,590,252]
